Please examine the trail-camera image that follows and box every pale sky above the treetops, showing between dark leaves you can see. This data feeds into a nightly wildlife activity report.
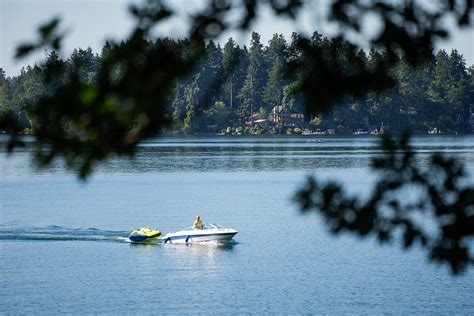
[0,0,474,76]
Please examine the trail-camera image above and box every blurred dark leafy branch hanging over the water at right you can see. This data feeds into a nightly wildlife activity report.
[295,134,474,274]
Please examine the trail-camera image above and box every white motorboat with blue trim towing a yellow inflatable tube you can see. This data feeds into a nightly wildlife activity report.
[159,224,238,244]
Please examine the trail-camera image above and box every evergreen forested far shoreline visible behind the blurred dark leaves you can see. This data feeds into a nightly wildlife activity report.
[0,32,474,134]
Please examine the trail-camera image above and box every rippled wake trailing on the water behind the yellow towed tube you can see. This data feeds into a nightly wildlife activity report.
[0,225,129,242]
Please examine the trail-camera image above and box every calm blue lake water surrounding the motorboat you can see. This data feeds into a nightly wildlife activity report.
[0,136,474,315]
